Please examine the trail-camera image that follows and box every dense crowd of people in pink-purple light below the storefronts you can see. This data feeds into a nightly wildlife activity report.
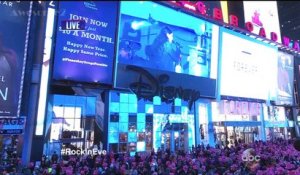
[0,139,300,175]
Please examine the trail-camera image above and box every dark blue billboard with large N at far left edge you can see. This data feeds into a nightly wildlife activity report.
[0,1,30,116]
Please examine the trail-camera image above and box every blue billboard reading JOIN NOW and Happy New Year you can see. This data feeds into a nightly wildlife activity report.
[53,1,118,84]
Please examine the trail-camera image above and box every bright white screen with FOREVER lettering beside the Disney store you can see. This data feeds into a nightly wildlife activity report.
[220,28,277,100]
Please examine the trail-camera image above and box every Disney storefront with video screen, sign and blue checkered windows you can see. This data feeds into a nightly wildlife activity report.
[107,2,219,155]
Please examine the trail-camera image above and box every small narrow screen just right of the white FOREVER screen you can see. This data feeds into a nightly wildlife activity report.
[276,51,294,105]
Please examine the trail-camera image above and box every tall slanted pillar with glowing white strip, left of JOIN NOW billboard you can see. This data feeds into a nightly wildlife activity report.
[22,1,56,165]
